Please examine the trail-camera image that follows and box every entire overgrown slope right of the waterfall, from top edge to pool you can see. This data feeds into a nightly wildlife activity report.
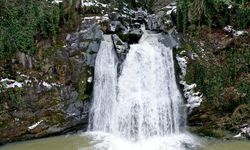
[176,0,250,132]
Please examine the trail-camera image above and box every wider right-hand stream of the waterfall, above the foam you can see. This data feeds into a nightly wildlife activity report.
[115,35,184,140]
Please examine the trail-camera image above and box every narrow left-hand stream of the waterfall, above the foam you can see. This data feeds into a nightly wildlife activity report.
[89,35,118,132]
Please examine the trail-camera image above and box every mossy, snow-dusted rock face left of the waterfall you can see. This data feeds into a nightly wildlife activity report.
[0,15,103,144]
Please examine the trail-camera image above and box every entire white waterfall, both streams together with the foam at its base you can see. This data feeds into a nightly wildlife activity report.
[89,33,199,150]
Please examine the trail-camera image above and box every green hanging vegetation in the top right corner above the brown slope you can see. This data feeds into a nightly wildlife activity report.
[177,0,250,32]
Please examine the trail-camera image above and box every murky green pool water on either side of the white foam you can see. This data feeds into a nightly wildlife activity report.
[0,134,250,150]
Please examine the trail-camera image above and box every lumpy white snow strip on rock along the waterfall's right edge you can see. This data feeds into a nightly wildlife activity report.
[176,55,202,113]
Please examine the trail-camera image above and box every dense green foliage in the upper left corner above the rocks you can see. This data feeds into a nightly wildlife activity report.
[0,0,80,59]
